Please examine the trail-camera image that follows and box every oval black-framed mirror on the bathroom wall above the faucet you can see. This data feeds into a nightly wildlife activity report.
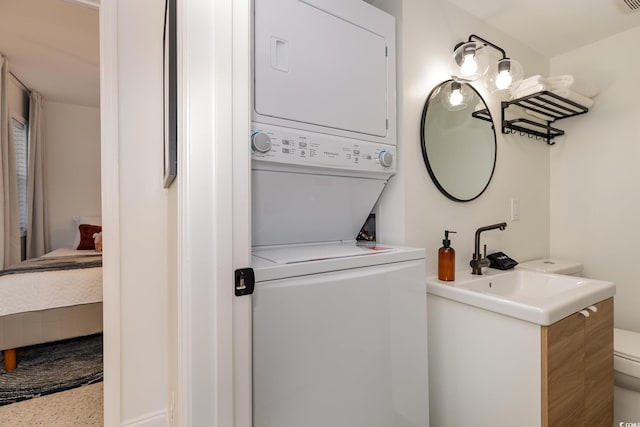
[420,80,496,202]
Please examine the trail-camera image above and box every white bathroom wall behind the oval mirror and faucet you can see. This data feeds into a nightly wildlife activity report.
[375,0,549,275]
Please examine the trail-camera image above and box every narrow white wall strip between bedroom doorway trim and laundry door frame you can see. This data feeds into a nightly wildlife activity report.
[117,0,169,426]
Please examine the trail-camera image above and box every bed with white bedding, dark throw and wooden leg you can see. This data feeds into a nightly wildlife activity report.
[0,248,102,370]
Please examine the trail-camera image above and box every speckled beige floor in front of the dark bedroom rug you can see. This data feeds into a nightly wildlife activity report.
[0,382,104,427]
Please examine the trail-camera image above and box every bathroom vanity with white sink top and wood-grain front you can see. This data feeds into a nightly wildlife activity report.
[427,269,615,427]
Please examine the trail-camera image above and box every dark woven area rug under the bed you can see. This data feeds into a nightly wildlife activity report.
[0,334,103,406]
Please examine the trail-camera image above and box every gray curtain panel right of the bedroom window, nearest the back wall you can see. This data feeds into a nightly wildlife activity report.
[27,91,48,258]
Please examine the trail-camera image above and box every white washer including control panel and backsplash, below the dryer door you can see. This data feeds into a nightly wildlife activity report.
[252,126,429,427]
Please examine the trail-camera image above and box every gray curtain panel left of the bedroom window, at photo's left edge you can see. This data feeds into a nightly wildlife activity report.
[0,54,20,269]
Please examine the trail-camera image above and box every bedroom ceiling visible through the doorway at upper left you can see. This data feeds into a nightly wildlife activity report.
[0,0,100,107]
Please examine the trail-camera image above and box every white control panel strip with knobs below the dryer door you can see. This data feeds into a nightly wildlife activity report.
[251,123,396,174]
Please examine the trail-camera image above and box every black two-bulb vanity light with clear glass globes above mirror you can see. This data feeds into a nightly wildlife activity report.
[450,34,524,93]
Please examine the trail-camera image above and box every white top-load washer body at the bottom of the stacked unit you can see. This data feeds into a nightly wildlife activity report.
[253,243,429,427]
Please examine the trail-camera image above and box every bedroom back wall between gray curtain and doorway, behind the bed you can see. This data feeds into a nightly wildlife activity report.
[44,100,101,250]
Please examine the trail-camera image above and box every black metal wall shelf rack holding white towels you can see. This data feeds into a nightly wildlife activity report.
[502,90,589,145]
